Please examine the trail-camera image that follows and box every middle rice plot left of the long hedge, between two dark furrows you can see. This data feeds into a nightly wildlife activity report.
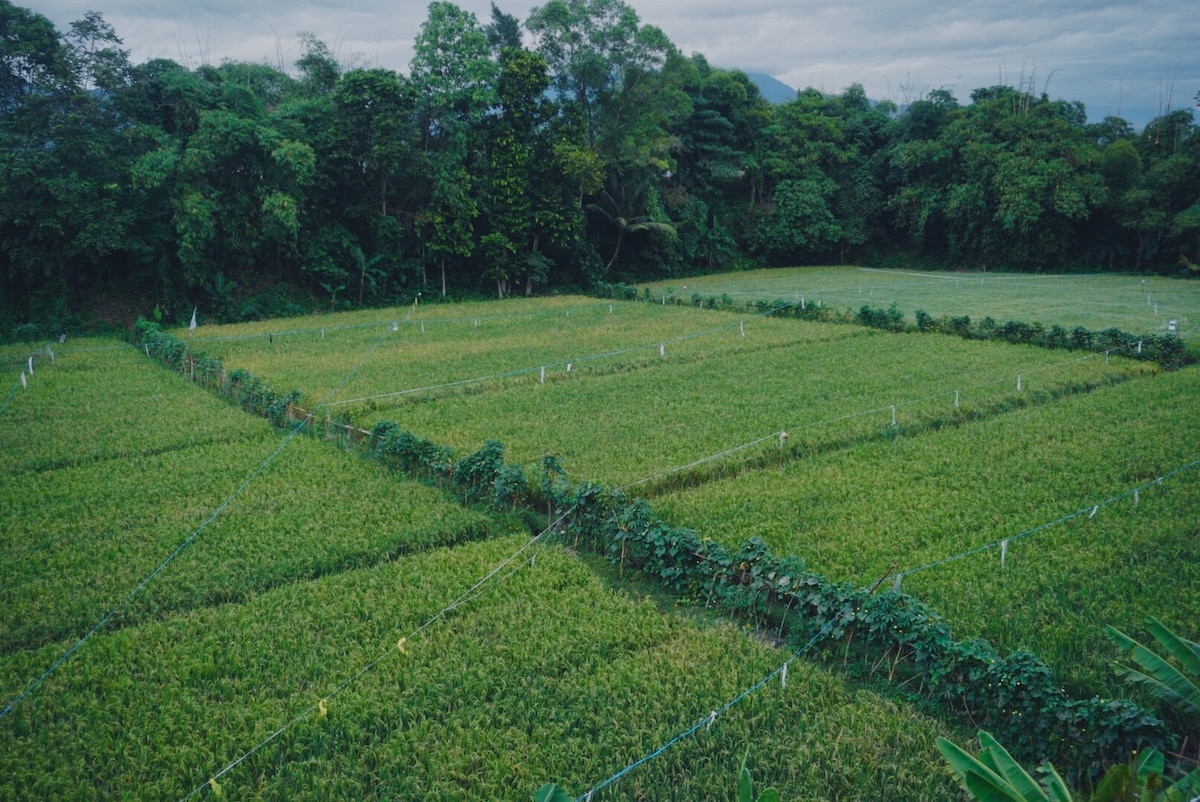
[0,429,493,653]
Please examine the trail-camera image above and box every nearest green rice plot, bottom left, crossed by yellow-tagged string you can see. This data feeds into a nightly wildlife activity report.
[0,537,956,802]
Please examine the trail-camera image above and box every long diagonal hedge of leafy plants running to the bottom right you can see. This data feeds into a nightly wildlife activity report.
[134,314,1176,777]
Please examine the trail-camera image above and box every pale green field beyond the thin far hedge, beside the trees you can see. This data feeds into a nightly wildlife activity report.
[638,268,1200,339]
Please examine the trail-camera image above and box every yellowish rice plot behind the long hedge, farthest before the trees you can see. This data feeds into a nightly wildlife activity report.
[196,298,848,408]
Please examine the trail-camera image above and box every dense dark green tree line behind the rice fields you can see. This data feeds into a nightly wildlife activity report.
[0,0,1200,323]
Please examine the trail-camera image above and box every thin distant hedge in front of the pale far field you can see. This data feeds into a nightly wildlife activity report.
[585,285,1189,367]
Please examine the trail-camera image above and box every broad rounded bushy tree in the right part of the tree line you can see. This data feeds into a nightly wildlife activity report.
[892,86,1105,269]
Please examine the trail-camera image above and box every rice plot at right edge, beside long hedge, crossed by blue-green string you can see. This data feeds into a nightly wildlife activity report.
[656,370,1200,694]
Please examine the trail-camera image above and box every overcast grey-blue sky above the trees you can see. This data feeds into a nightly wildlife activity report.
[28,0,1200,126]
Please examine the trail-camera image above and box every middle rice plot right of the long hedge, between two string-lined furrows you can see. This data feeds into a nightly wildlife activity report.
[350,322,1154,495]
